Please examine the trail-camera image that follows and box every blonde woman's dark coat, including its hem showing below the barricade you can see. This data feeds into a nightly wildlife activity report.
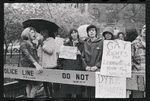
[18,40,39,86]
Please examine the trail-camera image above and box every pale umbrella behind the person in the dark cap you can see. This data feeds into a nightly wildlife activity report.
[77,25,89,39]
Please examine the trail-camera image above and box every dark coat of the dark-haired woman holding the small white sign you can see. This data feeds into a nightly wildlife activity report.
[61,40,84,94]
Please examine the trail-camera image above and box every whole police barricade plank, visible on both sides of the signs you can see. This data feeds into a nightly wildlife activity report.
[4,66,145,98]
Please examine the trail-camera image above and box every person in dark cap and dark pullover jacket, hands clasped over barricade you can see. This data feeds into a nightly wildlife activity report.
[82,25,103,98]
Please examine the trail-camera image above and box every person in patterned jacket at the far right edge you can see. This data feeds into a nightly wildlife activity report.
[131,25,146,98]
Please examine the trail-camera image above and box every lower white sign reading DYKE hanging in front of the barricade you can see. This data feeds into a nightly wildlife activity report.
[95,72,126,98]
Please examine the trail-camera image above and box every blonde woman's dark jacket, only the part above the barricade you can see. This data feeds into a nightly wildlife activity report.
[20,40,38,68]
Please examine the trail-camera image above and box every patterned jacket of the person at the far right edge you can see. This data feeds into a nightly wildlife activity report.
[131,36,146,71]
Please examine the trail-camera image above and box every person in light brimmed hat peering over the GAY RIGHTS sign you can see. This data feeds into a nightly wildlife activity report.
[102,27,114,40]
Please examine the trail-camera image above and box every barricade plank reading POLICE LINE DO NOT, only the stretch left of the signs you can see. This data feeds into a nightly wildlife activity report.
[4,66,95,86]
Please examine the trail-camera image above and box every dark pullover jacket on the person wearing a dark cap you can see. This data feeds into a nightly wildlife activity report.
[82,37,103,70]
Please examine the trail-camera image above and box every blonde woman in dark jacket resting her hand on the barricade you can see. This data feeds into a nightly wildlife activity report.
[20,27,42,98]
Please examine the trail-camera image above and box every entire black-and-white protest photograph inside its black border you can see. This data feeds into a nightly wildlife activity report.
[3,2,146,99]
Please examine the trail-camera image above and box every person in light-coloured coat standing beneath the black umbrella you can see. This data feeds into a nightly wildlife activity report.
[40,30,60,98]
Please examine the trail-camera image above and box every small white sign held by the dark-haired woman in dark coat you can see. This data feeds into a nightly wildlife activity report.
[59,45,77,60]
